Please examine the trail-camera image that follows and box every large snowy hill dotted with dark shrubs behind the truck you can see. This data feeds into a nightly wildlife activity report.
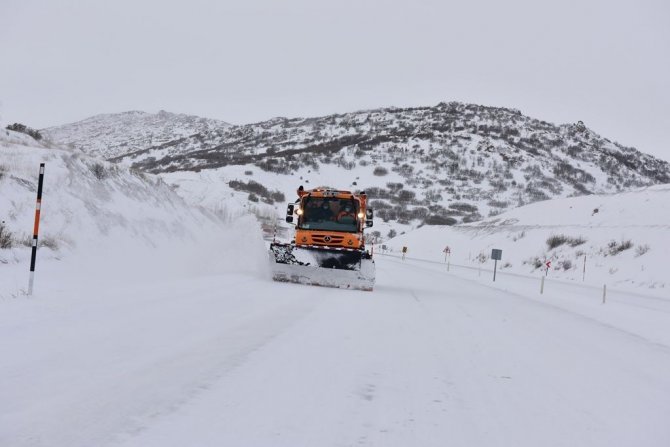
[43,102,670,233]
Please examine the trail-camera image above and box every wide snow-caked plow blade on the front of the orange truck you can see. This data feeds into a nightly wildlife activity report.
[270,243,375,291]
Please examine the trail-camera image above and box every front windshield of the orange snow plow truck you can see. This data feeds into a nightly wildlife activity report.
[299,197,358,233]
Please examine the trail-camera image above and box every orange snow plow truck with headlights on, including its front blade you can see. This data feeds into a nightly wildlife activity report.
[270,186,375,291]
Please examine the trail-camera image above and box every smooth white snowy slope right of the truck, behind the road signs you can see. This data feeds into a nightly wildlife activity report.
[385,185,670,297]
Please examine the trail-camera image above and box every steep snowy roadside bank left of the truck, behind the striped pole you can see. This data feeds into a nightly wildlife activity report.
[0,130,263,295]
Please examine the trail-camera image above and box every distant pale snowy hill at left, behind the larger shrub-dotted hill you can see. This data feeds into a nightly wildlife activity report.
[40,110,229,158]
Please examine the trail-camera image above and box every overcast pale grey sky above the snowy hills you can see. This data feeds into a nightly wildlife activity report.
[0,0,670,160]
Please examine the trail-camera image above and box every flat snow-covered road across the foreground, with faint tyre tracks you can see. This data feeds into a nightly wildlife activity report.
[0,257,670,447]
